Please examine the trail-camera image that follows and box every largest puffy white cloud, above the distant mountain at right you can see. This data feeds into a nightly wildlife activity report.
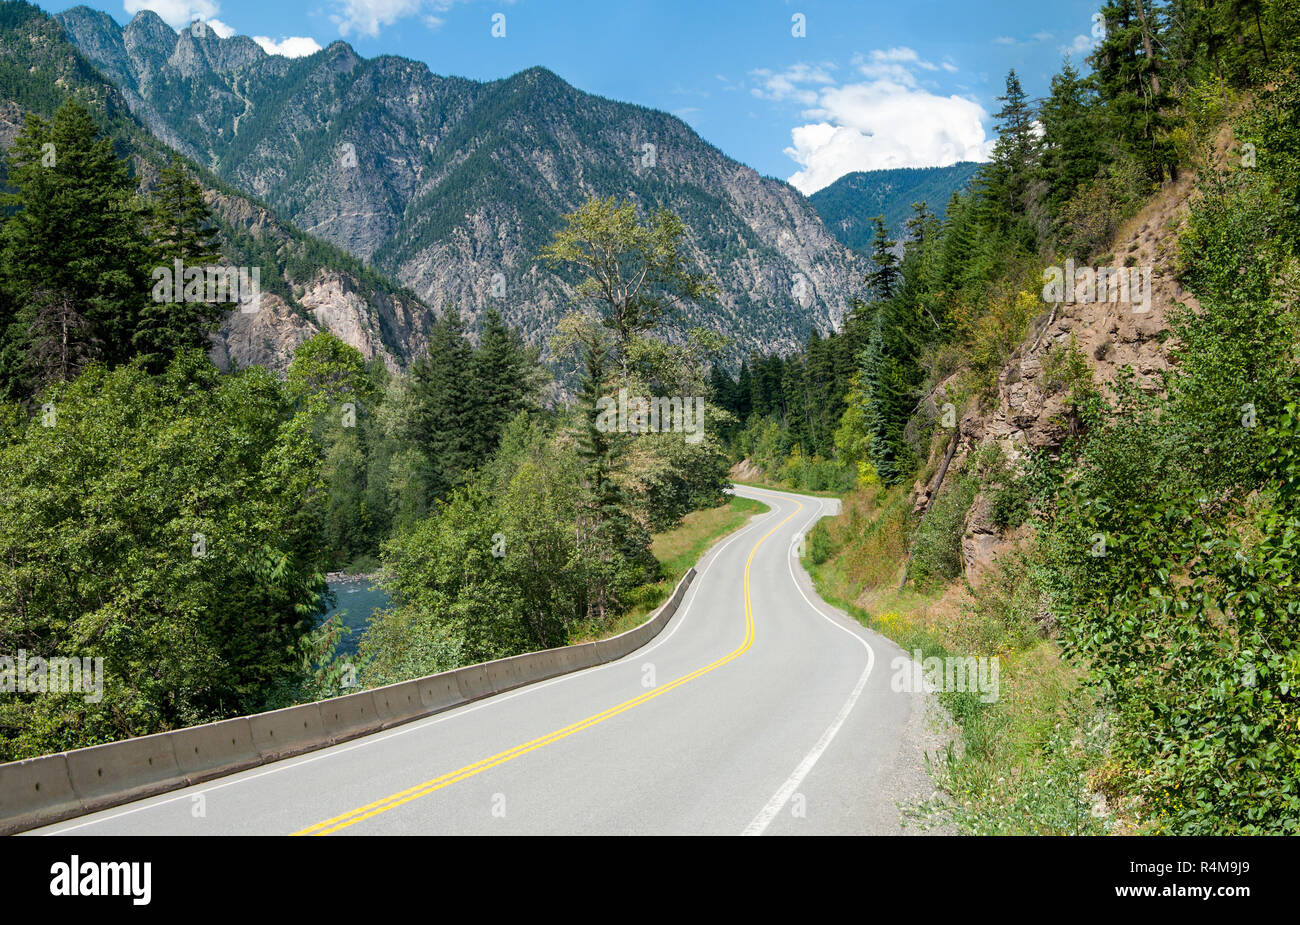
[769,48,993,194]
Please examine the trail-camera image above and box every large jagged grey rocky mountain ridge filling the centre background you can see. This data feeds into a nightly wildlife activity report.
[57,6,866,360]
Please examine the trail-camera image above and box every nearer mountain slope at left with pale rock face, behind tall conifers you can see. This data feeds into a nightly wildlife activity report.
[0,3,434,370]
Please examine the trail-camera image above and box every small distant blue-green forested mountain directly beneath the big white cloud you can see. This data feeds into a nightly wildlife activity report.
[809,161,980,249]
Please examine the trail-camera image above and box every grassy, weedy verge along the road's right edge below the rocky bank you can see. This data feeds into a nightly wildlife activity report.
[805,480,1113,834]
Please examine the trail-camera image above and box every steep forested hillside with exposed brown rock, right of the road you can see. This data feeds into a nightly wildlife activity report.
[714,0,1300,834]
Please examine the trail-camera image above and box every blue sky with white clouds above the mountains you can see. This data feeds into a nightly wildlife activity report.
[45,0,1099,194]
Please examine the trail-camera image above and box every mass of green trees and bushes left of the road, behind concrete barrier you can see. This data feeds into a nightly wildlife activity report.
[0,99,753,760]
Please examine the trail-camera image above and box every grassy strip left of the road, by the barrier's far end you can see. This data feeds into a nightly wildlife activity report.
[569,498,770,644]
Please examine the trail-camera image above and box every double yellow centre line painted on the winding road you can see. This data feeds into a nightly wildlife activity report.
[294,504,803,835]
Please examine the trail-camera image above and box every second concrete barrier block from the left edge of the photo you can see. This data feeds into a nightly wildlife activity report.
[66,733,187,812]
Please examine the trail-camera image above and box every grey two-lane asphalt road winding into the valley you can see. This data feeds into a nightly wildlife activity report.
[31,486,935,835]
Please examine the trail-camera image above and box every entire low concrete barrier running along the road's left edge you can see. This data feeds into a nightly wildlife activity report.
[0,569,696,835]
